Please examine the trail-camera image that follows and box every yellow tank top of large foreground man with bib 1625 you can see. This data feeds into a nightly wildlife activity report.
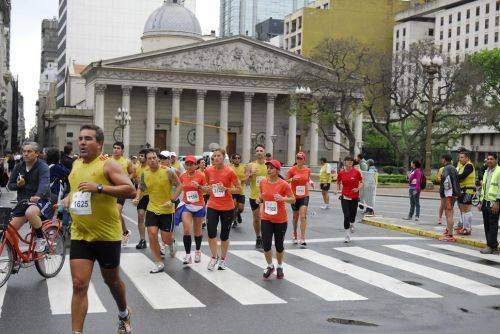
[69,156,122,242]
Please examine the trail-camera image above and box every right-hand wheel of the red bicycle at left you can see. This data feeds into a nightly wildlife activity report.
[35,226,66,278]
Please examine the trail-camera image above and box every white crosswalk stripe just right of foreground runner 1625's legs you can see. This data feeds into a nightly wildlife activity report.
[120,253,205,310]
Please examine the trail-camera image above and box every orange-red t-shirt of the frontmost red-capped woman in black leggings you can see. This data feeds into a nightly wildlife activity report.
[259,178,293,224]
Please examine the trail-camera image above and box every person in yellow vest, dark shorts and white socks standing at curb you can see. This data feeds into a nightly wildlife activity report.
[455,151,476,235]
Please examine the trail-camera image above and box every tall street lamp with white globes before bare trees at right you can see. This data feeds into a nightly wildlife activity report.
[420,55,443,180]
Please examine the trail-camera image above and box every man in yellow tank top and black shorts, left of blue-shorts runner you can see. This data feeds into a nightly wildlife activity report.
[140,150,182,274]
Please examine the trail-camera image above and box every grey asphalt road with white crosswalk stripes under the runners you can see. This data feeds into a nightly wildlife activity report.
[0,194,500,334]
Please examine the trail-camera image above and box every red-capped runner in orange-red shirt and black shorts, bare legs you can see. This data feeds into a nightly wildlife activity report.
[286,152,311,248]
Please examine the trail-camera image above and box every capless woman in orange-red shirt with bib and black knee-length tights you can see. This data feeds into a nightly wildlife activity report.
[202,149,241,271]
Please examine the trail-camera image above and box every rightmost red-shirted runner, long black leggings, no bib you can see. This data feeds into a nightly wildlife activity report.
[337,157,363,243]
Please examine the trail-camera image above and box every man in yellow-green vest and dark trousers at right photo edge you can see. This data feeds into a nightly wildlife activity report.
[478,153,500,254]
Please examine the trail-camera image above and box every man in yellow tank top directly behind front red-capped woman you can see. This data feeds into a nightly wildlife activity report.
[246,145,267,248]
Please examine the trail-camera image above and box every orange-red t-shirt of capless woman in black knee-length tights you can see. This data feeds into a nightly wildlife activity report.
[205,166,238,211]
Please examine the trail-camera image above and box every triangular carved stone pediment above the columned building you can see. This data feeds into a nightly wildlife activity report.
[102,36,309,77]
